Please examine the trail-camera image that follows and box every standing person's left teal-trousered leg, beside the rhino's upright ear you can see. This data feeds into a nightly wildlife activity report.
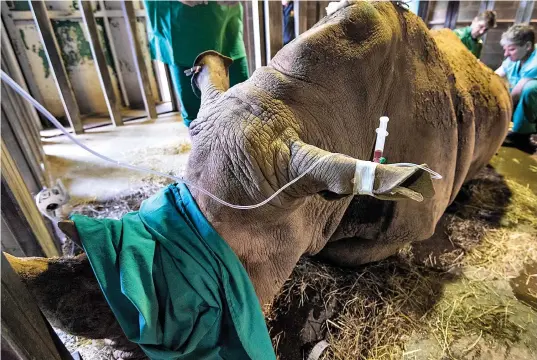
[170,65,201,127]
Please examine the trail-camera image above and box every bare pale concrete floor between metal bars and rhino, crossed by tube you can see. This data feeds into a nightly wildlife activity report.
[42,113,190,203]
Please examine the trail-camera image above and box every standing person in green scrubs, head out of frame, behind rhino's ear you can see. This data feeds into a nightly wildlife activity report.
[144,0,248,126]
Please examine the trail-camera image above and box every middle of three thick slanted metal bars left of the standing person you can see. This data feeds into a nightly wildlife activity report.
[78,0,123,126]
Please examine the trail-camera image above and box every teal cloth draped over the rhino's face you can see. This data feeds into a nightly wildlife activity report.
[71,184,276,360]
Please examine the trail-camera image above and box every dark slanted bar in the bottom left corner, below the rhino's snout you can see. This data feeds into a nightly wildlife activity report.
[1,253,73,360]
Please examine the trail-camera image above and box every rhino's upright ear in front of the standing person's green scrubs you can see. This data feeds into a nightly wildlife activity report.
[185,50,233,103]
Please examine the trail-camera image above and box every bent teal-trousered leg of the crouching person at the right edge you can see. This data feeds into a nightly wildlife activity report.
[512,80,537,134]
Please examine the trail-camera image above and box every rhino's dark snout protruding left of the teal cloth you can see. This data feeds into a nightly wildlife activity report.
[6,254,123,339]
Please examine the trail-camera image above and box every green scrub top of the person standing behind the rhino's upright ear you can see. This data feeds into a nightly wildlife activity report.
[144,0,246,67]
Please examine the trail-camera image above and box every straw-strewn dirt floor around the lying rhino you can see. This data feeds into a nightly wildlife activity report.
[53,149,537,360]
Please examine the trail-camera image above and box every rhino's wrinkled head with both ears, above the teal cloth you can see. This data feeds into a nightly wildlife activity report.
[182,51,434,303]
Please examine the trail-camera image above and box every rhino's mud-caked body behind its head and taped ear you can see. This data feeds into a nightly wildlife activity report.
[262,2,510,263]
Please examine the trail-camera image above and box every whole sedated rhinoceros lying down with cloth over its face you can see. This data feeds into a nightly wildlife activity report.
[10,1,512,354]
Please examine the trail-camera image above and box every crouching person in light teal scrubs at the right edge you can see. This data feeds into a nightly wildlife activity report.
[496,25,537,148]
